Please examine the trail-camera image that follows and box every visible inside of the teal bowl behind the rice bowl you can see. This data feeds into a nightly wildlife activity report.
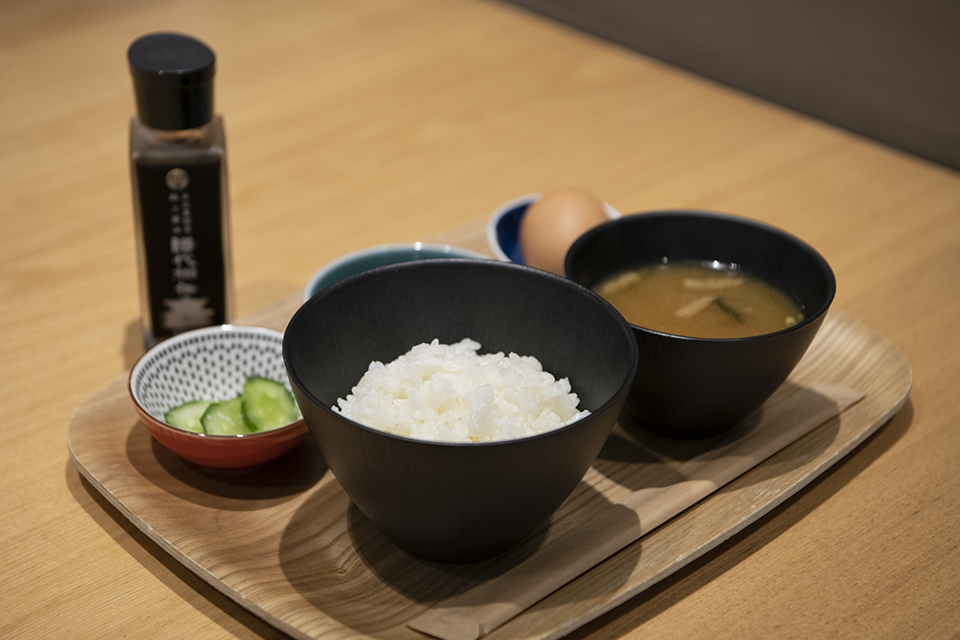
[303,242,486,302]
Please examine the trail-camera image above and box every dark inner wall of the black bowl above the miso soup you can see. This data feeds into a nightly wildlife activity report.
[565,211,836,327]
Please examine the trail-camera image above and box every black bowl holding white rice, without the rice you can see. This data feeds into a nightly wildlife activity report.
[283,259,637,563]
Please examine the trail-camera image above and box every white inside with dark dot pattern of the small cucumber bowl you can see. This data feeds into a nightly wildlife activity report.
[130,325,298,422]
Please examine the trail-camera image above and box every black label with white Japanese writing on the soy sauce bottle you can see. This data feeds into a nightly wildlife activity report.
[136,159,227,339]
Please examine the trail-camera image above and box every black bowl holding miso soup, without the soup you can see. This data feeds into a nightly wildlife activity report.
[564,211,836,438]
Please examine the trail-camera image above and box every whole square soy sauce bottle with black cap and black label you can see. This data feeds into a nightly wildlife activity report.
[127,33,233,349]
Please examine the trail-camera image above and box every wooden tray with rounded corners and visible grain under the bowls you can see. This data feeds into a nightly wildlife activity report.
[68,224,912,640]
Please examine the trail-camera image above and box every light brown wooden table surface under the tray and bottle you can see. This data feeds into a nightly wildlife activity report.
[0,0,960,640]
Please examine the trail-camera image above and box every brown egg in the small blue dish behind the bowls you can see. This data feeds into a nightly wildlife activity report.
[520,187,608,275]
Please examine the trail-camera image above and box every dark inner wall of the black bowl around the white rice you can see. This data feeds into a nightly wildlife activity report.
[284,260,636,424]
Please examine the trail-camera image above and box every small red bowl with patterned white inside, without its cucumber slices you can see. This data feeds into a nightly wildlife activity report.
[128,325,307,469]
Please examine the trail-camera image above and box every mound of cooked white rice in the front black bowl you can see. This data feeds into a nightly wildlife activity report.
[333,338,590,442]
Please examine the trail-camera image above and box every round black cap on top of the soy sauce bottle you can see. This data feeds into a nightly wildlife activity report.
[127,33,216,130]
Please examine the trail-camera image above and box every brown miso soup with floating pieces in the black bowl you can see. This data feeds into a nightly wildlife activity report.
[594,261,803,338]
